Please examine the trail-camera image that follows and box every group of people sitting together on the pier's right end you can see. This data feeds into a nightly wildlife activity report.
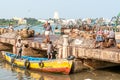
[94,28,115,49]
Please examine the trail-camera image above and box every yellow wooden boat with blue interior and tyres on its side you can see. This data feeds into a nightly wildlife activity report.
[2,51,72,74]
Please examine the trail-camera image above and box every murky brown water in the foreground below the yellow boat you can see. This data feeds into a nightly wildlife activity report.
[0,54,120,80]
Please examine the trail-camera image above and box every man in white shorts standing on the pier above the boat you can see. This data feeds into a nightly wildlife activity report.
[44,22,52,42]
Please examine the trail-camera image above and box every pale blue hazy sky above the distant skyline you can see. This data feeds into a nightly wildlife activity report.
[0,0,120,19]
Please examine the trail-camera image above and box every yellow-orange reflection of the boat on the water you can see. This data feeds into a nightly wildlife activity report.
[2,63,71,80]
